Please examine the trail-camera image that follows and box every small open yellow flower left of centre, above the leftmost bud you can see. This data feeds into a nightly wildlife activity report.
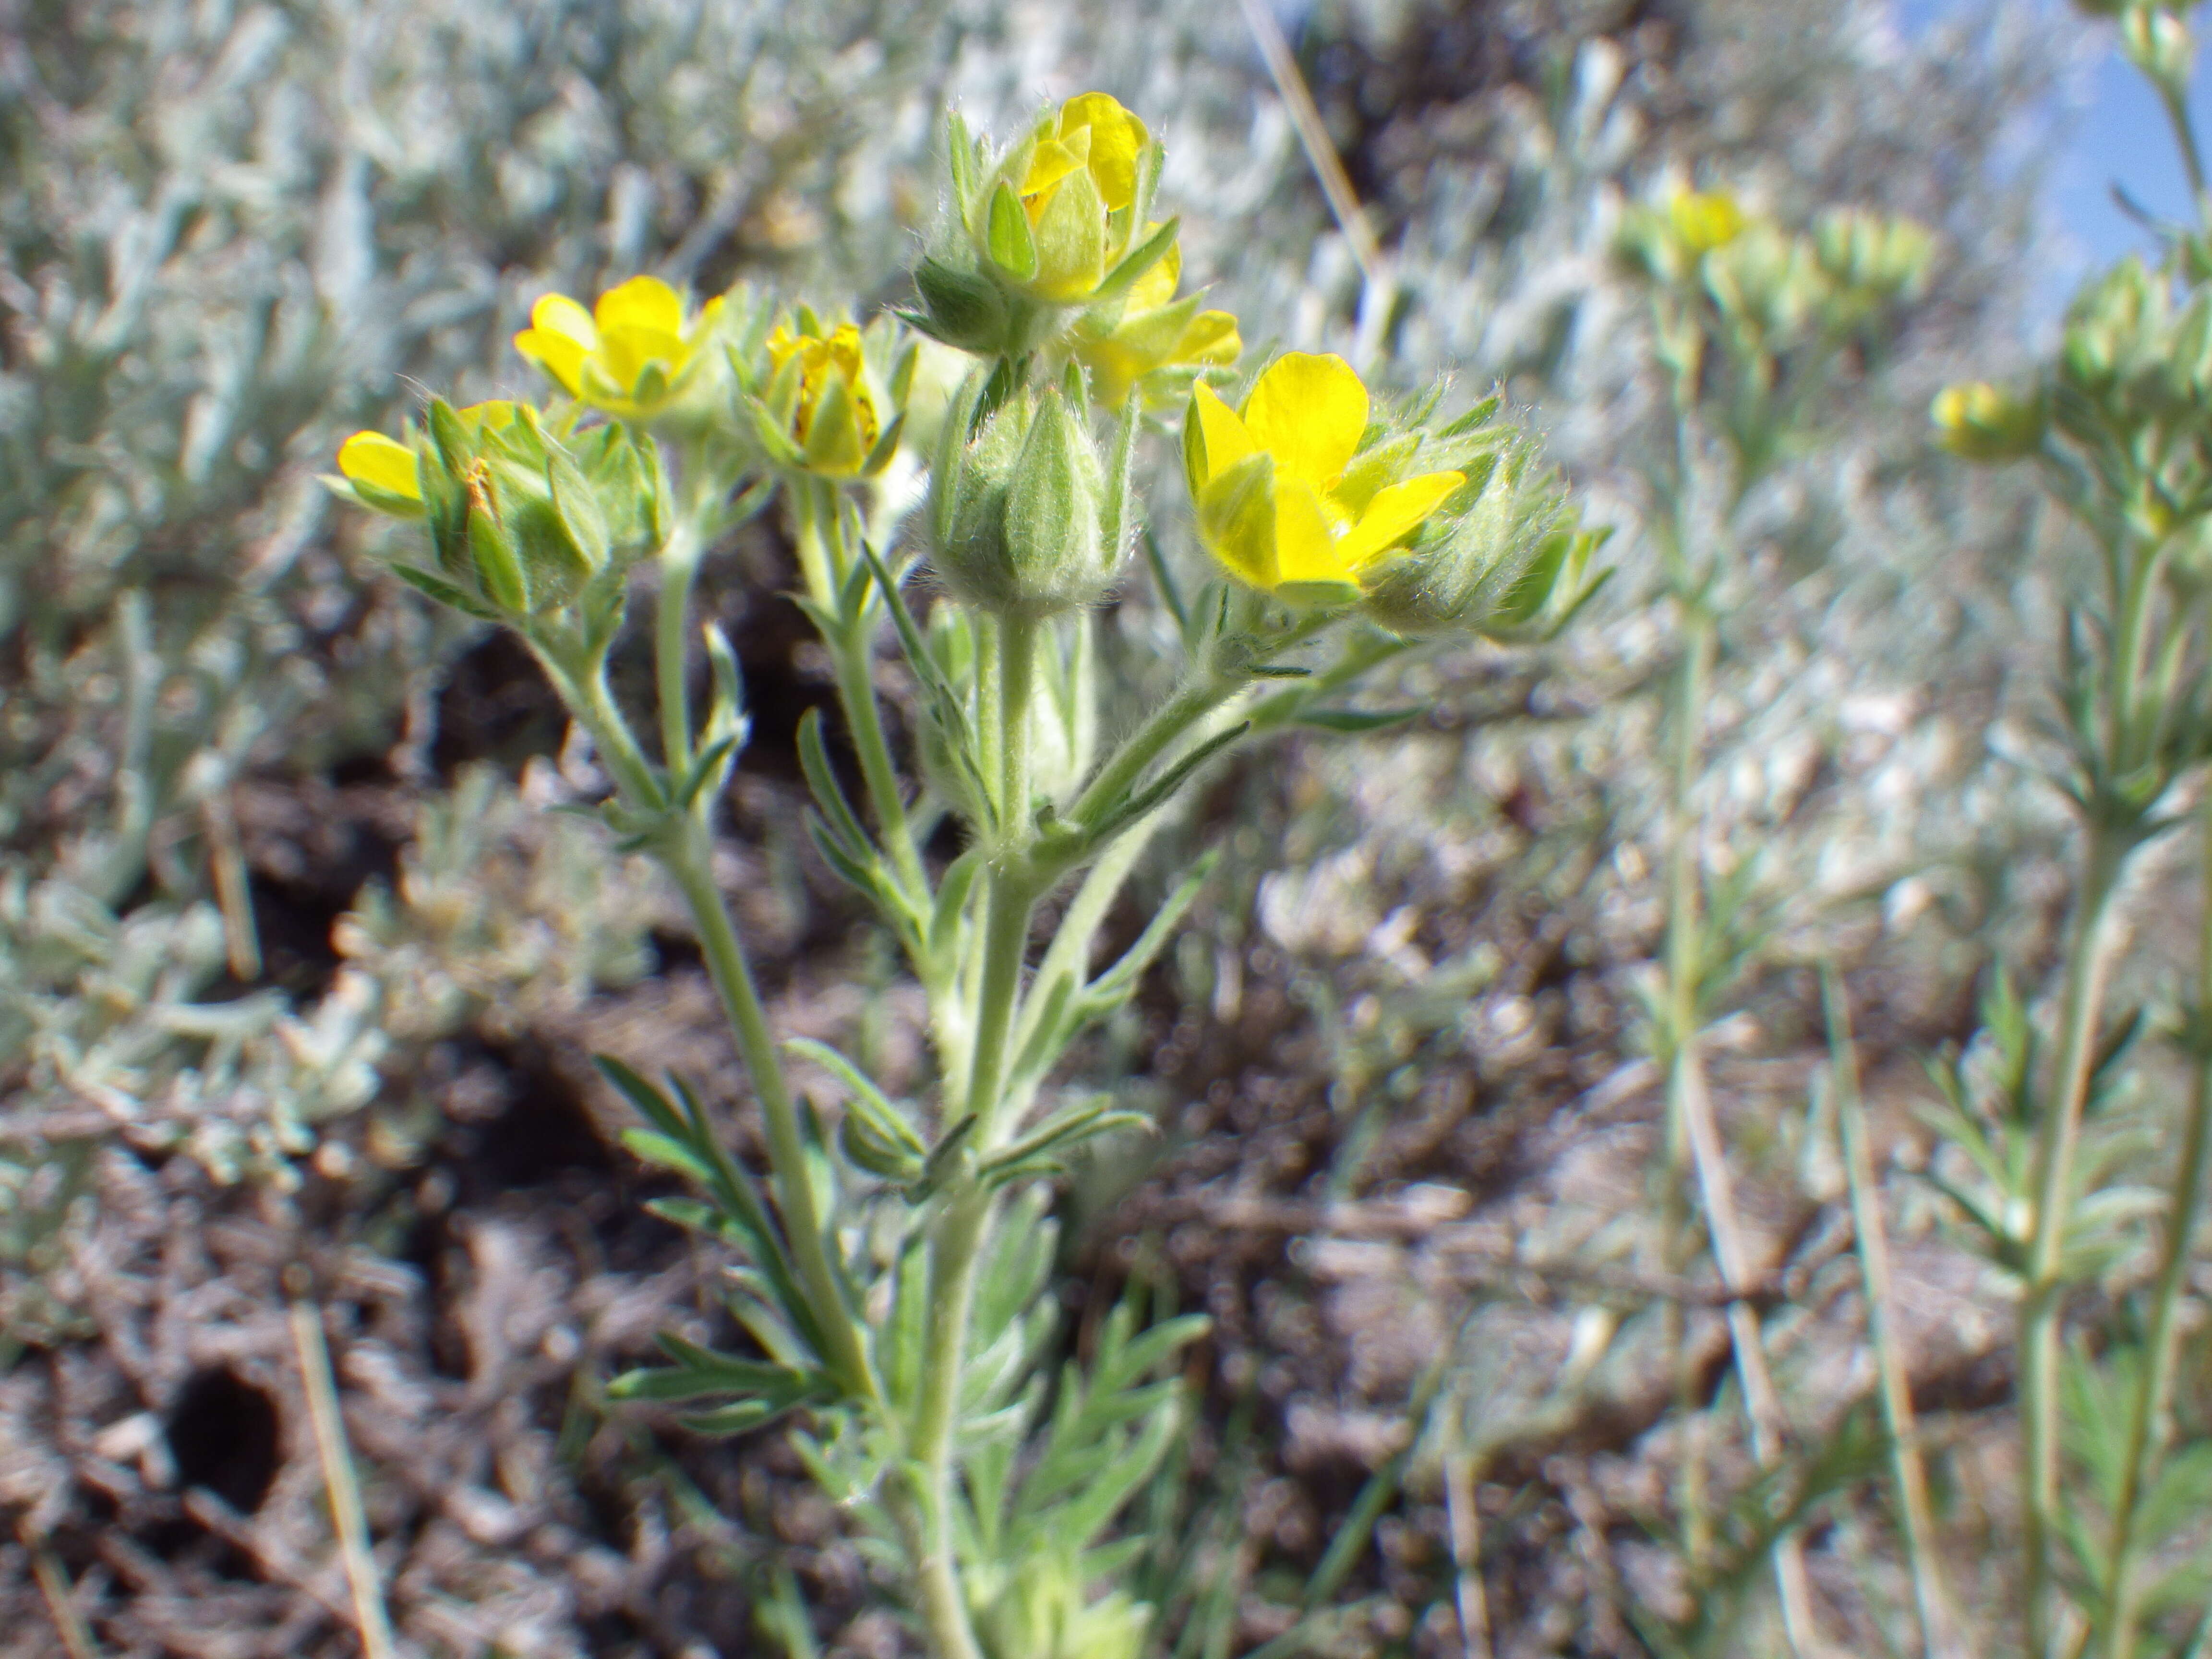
[516,276,721,421]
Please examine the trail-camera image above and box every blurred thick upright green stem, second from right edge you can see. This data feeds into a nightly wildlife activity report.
[2017,821,2126,1659]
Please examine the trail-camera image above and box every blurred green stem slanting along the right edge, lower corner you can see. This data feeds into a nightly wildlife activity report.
[2106,794,2212,1659]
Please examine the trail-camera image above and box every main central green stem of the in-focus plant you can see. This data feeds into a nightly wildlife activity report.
[911,617,1037,1659]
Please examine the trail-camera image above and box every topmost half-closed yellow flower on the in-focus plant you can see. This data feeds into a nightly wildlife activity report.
[975,93,1153,305]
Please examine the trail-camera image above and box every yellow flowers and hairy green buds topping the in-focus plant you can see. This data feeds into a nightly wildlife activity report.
[338,93,1575,630]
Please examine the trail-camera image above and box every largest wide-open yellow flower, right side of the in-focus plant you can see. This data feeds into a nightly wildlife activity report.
[1183,352,1467,600]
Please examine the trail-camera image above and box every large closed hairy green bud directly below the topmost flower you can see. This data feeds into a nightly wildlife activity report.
[929,376,1121,617]
